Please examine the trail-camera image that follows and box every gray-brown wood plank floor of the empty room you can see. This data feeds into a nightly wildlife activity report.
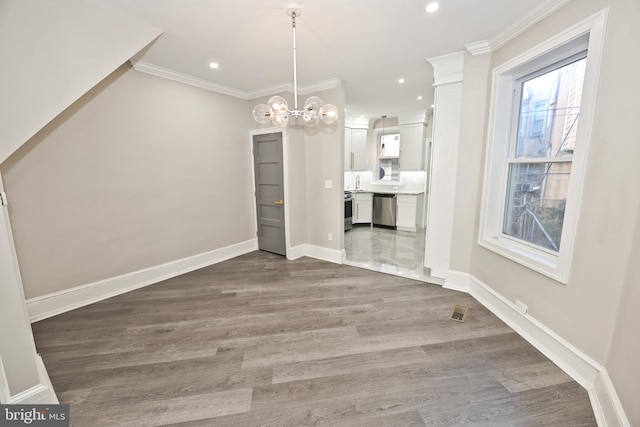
[33,252,596,427]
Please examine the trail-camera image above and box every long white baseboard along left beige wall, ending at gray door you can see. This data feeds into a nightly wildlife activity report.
[27,239,258,322]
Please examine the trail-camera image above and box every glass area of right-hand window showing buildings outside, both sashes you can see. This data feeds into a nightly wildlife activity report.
[503,56,586,252]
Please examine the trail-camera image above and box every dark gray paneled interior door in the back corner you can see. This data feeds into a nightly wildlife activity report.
[253,132,287,256]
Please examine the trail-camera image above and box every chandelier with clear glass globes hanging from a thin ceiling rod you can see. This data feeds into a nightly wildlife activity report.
[253,6,338,127]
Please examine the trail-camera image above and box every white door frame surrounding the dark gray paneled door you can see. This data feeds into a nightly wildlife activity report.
[249,127,292,259]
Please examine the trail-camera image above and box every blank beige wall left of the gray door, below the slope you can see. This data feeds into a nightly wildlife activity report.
[0,65,255,298]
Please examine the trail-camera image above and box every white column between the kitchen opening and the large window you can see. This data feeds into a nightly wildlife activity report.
[424,52,464,279]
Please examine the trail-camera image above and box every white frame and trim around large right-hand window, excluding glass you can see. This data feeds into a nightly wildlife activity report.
[478,9,608,284]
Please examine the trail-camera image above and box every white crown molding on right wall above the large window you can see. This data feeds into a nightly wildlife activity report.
[464,0,571,55]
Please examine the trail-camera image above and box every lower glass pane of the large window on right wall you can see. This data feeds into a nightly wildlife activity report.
[503,162,571,252]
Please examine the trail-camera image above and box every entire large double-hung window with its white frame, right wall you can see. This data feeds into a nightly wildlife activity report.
[478,11,606,283]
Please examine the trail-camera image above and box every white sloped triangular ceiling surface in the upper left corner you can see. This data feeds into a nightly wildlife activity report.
[0,0,162,163]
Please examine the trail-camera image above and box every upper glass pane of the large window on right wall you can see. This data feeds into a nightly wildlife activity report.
[515,58,587,158]
